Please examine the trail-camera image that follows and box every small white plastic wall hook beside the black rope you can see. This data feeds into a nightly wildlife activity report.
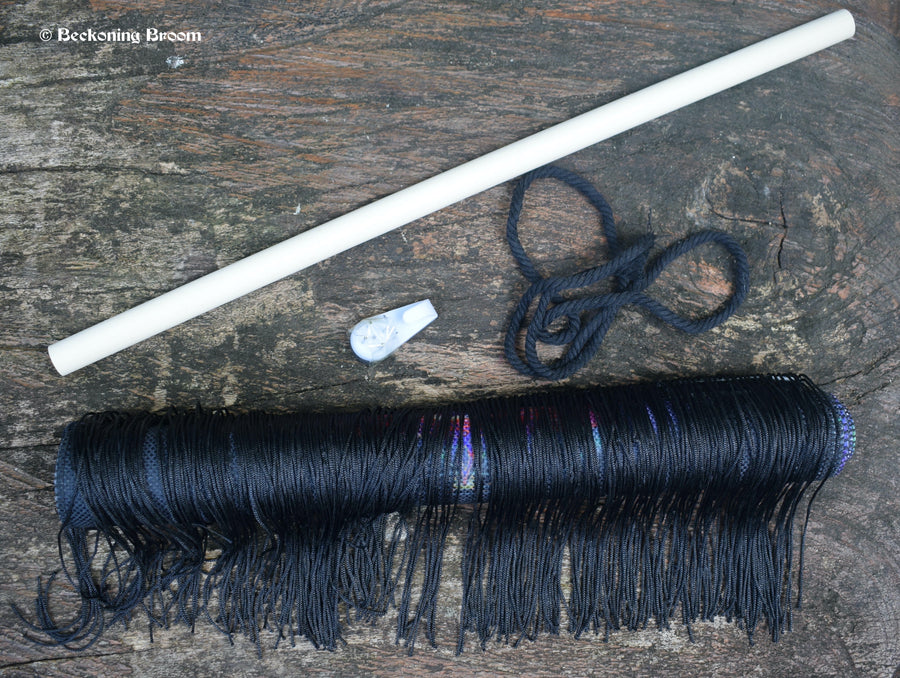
[350,299,437,363]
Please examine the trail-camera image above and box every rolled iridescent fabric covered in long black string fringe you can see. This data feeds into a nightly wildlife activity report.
[33,375,855,651]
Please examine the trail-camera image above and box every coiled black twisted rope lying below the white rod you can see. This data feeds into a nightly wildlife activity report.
[504,165,750,379]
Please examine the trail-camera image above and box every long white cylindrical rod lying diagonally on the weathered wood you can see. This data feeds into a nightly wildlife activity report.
[48,10,855,374]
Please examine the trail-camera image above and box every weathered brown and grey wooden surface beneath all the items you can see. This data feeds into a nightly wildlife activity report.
[0,0,900,677]
